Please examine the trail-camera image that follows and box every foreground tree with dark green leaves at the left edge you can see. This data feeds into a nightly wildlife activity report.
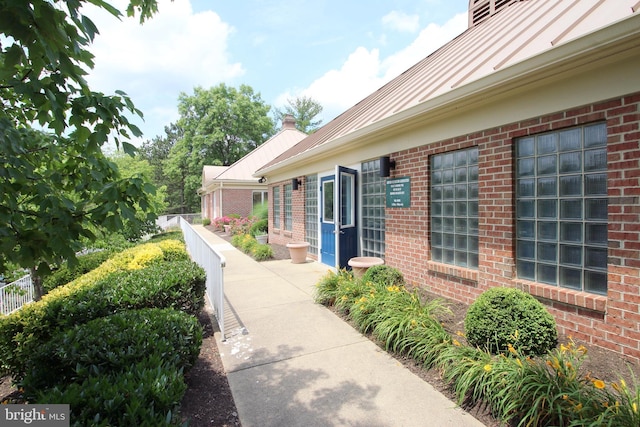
[0,0,157,295]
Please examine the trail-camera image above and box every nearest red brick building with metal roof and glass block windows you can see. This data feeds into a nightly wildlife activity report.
[256,0,640,359]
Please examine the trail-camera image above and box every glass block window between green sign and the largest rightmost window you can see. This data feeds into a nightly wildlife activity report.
[431,147,478,269]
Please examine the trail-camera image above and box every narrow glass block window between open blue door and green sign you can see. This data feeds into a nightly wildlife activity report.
[361,159,386,258]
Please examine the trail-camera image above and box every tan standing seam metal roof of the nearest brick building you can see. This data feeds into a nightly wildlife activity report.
[264,0,640,174]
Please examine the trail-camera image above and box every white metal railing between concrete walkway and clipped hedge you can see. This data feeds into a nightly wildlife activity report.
[179,218,226,337]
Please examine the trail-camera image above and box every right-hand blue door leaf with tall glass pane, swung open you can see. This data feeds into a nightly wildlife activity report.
[336,166,358,268]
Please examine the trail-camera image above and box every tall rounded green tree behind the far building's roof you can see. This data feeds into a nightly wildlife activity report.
[165,84,274,212]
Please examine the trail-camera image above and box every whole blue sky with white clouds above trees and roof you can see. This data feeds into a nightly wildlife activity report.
[86,0,468,144]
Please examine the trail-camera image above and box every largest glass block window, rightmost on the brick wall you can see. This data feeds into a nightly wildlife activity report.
[515,123,608,294]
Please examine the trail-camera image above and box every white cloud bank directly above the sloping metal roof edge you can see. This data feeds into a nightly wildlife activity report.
[276,13,467,123]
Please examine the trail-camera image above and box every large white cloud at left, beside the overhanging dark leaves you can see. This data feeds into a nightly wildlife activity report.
[85,0,244,138]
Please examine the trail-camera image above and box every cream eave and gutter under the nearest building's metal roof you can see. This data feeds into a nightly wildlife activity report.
[253,14,640,177]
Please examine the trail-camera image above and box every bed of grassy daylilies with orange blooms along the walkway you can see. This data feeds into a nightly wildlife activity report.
[316,267,640,426]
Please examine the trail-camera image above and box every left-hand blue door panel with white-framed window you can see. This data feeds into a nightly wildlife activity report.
[320,175,336,267]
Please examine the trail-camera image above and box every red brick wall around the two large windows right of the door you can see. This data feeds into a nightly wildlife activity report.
[385,94,640,359]
